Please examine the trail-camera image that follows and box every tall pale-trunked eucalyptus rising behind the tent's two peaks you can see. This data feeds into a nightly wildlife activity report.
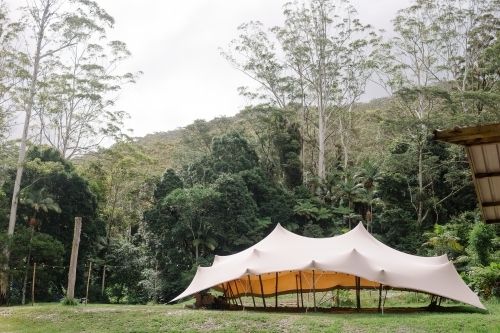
[222,0,378,179]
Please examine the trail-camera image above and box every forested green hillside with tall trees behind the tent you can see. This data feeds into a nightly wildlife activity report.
[0,0,500,303]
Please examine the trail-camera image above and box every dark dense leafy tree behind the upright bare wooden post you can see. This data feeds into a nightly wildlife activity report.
[3,146,105,300]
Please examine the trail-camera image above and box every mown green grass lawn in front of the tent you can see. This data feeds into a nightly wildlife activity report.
[0,301,500,333]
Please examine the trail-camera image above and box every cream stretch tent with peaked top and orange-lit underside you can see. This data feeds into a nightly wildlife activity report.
[172,223,485,309]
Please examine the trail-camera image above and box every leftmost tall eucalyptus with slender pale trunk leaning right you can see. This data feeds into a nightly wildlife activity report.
[0,0,120,299]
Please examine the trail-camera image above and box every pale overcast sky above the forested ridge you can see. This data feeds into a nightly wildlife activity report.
[9,0,410,136]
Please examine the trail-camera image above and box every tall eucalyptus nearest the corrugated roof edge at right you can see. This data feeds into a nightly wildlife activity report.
[378,0,500,224]
